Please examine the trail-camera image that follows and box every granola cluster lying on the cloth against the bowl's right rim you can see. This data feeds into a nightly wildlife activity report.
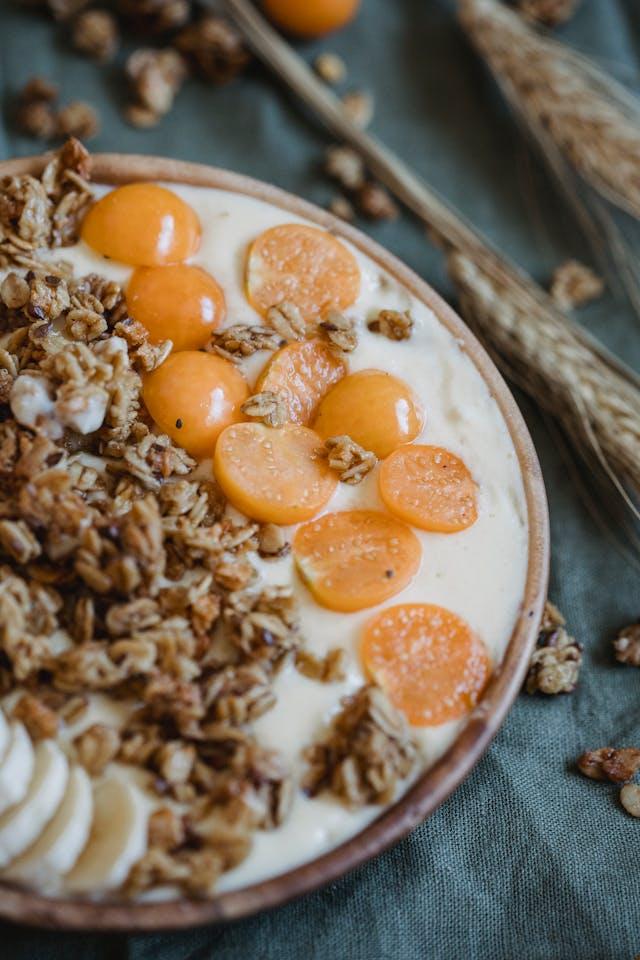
[525,603,582,696]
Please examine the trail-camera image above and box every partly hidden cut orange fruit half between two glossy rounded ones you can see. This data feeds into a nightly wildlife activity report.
[256,340,348,426]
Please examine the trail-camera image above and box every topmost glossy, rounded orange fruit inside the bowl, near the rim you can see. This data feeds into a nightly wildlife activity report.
[82,183,200,267]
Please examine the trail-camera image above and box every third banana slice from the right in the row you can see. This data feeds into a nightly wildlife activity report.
[0,740,69,868]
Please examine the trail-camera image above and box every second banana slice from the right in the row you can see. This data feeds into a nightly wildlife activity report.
[3,767,93,894]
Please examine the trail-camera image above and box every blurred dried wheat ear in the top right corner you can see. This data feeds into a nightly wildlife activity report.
[460,0,640,218]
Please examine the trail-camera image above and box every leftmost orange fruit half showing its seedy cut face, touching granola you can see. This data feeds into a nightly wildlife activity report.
[213,423,337,524]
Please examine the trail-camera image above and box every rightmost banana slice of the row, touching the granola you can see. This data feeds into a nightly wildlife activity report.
[65,775,148,893]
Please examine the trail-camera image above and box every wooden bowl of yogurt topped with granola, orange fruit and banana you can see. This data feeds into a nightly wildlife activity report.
[0,148,549,929]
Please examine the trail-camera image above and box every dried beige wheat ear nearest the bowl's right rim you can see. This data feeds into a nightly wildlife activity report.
[447,250,640,490]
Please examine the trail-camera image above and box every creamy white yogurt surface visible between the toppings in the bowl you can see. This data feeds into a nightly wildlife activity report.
[2,178,528,890]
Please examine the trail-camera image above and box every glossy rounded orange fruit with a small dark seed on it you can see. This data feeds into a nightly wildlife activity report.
[142,350,249,458]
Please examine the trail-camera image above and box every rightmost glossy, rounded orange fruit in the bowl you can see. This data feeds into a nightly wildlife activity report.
[313,370,424,460]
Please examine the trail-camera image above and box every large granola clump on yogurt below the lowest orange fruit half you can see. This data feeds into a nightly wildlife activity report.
[303,685,417,807]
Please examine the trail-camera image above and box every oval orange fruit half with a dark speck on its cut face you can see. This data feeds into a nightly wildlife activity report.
[292,510,422,613]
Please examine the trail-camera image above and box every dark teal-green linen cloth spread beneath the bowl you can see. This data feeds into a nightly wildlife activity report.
[0,0,640,960]
